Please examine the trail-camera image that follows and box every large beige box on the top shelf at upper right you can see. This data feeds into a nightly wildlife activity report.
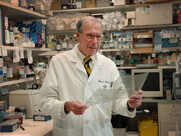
[136,3,172,25]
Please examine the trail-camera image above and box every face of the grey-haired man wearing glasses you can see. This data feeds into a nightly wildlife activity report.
[76,21,102,56]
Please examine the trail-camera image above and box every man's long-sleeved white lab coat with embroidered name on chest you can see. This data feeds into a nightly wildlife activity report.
[39,46,135,136]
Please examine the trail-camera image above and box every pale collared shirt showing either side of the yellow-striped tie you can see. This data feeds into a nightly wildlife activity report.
[77,46,96,70]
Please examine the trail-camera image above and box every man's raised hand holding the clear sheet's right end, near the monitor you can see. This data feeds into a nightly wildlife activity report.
[128,90,143,108]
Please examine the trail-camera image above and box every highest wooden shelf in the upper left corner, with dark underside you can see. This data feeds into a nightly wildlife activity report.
[0,1,46,20]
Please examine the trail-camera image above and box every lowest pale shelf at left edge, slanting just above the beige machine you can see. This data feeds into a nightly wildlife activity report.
[0,77,33,87]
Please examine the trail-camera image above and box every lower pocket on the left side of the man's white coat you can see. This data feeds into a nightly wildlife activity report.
[56,118,74,129]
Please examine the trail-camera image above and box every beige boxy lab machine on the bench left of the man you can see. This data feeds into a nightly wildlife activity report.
[9,89,39,118]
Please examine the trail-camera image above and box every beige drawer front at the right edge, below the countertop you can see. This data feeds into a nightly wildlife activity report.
[158,103,181,123]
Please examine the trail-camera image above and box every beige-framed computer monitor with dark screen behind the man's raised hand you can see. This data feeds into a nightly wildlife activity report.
[131,69,163,97]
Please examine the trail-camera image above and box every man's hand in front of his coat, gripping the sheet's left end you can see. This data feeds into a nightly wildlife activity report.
[65,101,88,115]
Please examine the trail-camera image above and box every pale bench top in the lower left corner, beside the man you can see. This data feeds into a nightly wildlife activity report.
[0,119,53,136]
